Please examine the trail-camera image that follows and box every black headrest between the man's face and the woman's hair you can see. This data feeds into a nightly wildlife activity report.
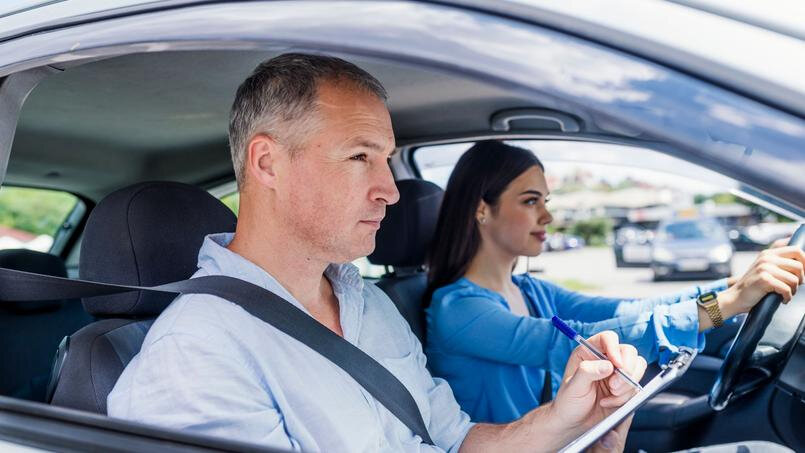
[369,179,444,268]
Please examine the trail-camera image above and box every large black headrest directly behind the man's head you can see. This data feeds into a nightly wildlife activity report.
[79,182,237,317]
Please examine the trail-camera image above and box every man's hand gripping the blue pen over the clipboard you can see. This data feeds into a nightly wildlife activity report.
[550,331,646,451]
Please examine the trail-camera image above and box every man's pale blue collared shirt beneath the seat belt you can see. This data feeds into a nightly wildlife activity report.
[107,233,472,452]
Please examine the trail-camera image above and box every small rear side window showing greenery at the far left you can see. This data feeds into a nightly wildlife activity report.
[0,187,83,252]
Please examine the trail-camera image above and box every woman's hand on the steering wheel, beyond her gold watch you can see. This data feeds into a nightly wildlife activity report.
[718,243,805,319]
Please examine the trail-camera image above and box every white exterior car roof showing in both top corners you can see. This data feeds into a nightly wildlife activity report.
[6,0,805,115]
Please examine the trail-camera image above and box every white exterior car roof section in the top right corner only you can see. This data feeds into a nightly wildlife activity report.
[506,0,805,114]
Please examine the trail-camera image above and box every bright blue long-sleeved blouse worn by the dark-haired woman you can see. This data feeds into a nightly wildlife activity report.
[426,275,726,423]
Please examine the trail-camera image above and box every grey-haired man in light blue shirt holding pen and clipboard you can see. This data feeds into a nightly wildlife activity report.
[108,54,796,451]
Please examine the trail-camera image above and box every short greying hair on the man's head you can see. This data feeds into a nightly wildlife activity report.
[229,53,388,189]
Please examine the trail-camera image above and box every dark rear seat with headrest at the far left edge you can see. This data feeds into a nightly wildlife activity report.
[0,249,93,401]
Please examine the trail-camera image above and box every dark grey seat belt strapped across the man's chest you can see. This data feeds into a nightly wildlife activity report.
[0,268,434,445]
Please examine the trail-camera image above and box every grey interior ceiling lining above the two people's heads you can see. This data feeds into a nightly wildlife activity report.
[7,50,552,197]
